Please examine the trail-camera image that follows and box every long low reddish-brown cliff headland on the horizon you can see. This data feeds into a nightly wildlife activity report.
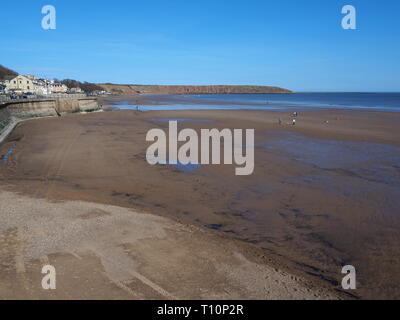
[98,83,292,95]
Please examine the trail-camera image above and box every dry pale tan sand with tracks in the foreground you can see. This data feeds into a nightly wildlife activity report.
[0,189,343,300]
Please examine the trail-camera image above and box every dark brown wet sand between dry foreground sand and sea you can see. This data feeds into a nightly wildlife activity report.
[0,106,400,299]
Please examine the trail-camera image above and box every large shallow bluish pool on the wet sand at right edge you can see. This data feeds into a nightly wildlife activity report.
[263,132,400,185]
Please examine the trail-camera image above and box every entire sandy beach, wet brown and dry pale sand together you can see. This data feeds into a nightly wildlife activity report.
[0,97,400,299]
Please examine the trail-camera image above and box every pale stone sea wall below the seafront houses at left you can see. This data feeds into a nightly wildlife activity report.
[0,98,99,143]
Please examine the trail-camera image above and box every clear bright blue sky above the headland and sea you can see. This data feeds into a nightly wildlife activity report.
[0,0,400,91]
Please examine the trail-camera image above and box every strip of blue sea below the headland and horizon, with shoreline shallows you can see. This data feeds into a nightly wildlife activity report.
[111,92,400,112]
